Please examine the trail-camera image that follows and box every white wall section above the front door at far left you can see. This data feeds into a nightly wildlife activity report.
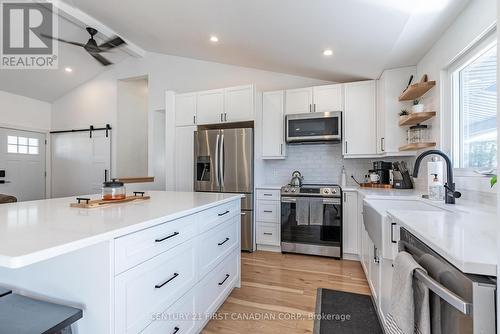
[0,91,51,131]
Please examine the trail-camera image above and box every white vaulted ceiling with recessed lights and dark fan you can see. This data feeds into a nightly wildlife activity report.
[0,0,470,101]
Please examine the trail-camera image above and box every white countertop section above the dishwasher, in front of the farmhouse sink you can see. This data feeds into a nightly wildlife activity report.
[388,210,498,276]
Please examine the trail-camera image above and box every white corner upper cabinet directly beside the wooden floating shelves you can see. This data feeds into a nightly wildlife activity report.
[377,66,416,155]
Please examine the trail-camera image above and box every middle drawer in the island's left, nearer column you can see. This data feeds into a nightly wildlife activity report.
[115,239,197,334]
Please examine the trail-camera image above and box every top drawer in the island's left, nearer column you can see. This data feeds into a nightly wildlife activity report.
[115,216,196,275]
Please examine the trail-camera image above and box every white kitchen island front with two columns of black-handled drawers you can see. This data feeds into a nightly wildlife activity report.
[114,199,241,334]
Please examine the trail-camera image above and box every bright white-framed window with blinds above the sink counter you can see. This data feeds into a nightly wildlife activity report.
[451,40,497,170]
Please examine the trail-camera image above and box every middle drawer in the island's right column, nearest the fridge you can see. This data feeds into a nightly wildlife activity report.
[198,216,241,278]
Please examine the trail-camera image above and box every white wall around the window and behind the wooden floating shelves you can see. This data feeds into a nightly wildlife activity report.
[416,0,497,194]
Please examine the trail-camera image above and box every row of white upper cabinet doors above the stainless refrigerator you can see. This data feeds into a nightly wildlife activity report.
[175,85,255,126]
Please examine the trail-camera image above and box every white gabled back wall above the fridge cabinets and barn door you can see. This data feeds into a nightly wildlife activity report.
[52,52,328,187]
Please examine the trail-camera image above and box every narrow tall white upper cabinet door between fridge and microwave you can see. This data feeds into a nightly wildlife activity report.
[262,91,285,159]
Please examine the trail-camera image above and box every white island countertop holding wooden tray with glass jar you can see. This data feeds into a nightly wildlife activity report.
[0,191,242,268]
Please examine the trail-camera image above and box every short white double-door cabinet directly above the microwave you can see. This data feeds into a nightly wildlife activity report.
[285,84,344,115]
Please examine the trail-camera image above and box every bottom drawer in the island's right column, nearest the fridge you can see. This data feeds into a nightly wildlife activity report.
[195,249,240,325]
